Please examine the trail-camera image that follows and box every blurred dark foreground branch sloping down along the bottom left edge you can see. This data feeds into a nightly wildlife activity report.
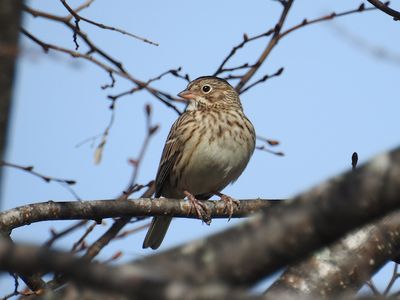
[0,240,260,300]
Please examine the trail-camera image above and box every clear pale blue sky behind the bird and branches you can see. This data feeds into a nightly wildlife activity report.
[2,0,400,296]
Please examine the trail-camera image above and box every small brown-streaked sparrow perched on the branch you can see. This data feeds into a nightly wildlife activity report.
[143,76,256,249]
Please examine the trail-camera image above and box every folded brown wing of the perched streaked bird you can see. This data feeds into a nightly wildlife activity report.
[155,113,190,197]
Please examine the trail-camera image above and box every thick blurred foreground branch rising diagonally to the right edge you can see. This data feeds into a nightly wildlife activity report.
[134,148,400,286]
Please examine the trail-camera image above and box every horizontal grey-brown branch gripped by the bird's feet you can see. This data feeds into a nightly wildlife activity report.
[0,198,281,232]
